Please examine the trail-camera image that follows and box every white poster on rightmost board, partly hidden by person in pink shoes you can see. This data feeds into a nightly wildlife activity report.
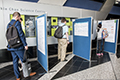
[102,20,116,43]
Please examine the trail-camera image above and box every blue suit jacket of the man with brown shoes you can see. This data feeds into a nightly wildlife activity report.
[7,19,27,51]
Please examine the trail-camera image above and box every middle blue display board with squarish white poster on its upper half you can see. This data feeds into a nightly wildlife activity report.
[73,17,92,61]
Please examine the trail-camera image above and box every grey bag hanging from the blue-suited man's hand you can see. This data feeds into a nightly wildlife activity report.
[22,50,31,77]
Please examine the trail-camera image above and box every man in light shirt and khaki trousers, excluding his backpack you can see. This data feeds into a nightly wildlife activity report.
[58,18,69,61]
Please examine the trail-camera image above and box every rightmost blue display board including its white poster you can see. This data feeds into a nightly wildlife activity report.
[101,20,119,54]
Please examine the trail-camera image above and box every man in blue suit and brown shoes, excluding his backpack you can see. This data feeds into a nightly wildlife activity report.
[7,12,36,80]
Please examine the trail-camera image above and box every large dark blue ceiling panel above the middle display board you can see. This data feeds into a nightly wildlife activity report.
[63,0,106,11]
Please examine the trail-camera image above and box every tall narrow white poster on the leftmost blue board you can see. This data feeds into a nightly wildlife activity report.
[37,17,45,55]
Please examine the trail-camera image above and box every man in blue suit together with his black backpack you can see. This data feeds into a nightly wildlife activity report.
[6,12,36,80]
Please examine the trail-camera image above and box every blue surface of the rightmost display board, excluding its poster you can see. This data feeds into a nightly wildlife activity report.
[102,20,119,54]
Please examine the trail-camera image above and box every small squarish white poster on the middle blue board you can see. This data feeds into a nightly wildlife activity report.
[74,22,88,36]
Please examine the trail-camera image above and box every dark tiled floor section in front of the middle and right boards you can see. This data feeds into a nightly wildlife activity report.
[52,53,110,79]
